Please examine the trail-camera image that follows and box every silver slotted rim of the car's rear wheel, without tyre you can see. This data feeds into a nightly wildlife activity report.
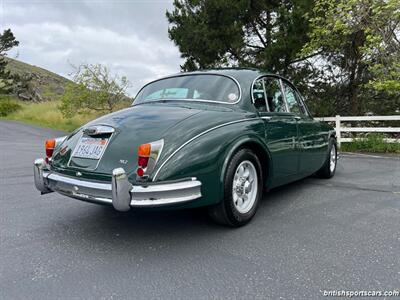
[232,160,258,214]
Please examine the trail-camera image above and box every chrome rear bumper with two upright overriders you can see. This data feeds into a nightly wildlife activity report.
[33,158,201,211]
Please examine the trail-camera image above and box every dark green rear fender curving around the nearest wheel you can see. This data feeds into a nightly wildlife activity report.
[156,118,265,207]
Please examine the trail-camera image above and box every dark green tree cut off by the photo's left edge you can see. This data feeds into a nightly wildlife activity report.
[0,29,19,93]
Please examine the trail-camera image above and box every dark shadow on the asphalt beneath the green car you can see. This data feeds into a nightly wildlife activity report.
[47,180,312,247]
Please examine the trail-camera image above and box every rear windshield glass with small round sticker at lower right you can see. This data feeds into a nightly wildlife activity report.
[134,74,240,104]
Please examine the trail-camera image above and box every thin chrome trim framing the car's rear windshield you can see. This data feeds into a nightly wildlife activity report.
[131,73,243,106]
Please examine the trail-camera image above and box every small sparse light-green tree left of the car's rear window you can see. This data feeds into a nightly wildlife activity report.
[60,64,131,117]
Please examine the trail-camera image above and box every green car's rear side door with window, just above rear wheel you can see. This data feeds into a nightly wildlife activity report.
[253,76,299,186]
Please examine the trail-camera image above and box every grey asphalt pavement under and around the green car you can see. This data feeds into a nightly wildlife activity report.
[0,121,400,299]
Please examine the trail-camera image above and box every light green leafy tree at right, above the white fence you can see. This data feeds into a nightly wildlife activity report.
[300,0,400,115]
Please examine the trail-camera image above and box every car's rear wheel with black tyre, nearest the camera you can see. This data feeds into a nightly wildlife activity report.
[209,149,263,227]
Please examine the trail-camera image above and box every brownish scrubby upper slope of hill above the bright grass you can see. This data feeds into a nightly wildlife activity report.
[6,57,71,100]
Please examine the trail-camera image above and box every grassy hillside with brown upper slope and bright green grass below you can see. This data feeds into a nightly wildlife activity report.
[0,58,132,131]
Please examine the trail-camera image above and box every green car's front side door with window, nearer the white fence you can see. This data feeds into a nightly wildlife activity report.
[282,80,326,174]
